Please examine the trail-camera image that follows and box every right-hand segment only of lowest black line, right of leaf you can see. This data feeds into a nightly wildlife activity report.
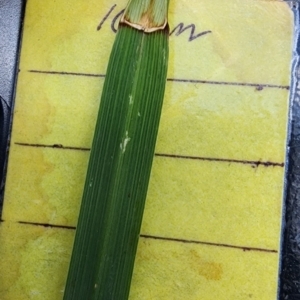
[140,234,278,253]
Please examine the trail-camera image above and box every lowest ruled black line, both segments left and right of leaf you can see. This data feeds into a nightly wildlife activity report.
[0,219,278,253]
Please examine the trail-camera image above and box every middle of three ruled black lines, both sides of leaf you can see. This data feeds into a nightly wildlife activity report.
[15,142,284,167]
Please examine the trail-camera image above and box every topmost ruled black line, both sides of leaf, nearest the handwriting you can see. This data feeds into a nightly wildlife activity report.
[28,70,290,91]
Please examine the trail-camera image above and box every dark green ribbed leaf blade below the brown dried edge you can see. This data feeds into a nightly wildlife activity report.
[64,0,169,300]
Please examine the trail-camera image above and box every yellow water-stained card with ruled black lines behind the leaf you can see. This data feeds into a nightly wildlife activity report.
[0,0,293,300]
